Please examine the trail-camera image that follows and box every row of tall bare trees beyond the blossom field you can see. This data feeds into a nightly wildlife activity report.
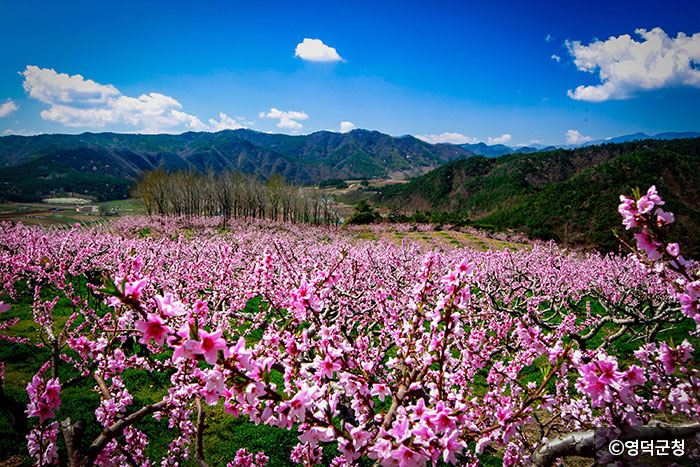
[134,169,339,226]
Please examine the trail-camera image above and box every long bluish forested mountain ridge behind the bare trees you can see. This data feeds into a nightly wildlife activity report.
[0,129,472,201]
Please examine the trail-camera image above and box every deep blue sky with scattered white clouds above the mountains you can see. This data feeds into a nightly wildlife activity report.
[0,1,700,146]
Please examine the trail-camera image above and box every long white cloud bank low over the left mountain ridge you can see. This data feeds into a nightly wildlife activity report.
[20,65,220,133]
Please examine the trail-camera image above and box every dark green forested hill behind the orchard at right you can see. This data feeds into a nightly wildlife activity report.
[378,138,700,256]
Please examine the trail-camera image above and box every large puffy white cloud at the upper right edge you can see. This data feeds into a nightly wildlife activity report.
[566,28,700,102]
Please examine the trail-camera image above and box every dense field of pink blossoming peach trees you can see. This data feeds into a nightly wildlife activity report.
[0,189,700,466]
